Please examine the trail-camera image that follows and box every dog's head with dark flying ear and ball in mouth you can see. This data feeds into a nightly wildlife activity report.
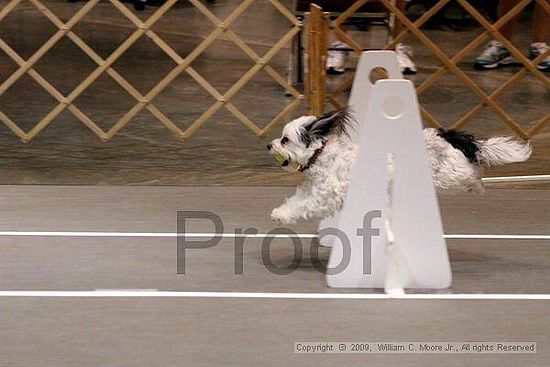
[267,110,352,171]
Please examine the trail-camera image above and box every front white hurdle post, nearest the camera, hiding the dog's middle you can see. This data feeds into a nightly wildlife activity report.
[327,53,452,294]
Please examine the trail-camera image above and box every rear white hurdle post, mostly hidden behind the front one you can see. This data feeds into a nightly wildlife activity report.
[319,51,403,247]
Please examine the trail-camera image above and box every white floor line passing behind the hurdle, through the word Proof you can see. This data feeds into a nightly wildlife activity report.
[0,231,550,240]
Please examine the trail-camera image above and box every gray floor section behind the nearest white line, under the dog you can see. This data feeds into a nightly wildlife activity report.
[0,186,550,293]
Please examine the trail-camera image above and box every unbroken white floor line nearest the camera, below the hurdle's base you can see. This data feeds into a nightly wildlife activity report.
[0,290,550,300]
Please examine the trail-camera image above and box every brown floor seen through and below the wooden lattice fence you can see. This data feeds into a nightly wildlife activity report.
[0,0,550,186]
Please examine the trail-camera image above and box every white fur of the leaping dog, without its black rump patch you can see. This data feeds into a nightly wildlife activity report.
[268,115,531,224]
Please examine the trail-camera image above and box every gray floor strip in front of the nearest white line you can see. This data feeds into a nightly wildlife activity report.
[0,298,550,367]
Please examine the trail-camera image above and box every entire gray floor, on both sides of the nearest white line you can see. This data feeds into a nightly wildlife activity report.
[0,186,550,366]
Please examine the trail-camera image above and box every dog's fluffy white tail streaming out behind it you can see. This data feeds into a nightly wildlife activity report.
[476,136,533,166]
